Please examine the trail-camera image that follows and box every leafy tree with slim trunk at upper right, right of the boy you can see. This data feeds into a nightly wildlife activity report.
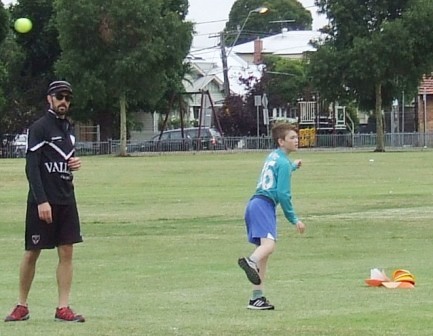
[310,0,433,152]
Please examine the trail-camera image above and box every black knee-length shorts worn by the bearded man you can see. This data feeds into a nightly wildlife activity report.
[25,203,83,250]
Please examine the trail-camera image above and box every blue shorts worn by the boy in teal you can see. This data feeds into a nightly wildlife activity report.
[245,196,277,245]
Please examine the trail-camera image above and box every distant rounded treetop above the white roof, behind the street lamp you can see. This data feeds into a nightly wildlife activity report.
[225,0,313,45]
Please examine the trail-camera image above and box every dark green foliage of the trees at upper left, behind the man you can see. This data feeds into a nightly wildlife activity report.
[0,0,192,137]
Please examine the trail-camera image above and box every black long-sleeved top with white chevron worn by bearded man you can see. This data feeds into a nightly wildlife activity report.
[26,110,75,204]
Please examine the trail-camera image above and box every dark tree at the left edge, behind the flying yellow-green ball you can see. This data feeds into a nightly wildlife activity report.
[0,0,60,132]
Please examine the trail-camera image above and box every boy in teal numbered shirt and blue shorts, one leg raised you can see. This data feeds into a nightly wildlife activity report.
[238,123,305,310]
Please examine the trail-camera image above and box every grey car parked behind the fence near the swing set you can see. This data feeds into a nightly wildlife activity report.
[141,127,225,152]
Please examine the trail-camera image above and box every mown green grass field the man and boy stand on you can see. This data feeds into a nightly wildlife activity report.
[0,151,433,336]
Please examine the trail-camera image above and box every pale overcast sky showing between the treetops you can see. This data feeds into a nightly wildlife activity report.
[1,0,326,48]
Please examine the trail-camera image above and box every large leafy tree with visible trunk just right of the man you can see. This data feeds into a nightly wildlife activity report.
[55,0,192,156]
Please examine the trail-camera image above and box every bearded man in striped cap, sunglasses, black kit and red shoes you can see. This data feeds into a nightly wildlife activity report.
[5,81,85,322]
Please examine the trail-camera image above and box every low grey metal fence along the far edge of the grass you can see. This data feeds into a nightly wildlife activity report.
[0,132,433,158]
